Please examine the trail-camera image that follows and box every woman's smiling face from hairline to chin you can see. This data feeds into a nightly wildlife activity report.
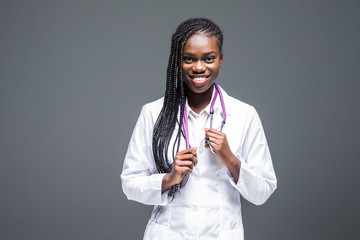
[183,32,223,93]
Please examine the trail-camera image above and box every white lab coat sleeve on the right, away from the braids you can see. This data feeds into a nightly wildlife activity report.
[228,107,277,205]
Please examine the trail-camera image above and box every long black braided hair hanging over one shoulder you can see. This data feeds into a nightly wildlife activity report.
[152,18,223,198]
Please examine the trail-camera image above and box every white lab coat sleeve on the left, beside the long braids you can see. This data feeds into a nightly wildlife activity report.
[121,105,168,206]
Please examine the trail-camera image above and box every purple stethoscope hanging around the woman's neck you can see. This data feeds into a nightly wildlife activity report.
[182,83,226,153]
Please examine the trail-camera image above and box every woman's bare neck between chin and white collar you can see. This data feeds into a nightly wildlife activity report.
[186,86,214,113]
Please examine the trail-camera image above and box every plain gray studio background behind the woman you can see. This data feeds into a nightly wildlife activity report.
[0,0,360,240]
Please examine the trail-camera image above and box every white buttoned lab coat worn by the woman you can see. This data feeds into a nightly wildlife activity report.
[121,85,277,240]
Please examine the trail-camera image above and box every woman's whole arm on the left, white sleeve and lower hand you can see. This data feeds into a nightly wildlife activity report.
[121,105,197,205]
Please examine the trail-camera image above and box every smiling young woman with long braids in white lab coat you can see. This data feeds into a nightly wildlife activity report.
[121,18,277,240]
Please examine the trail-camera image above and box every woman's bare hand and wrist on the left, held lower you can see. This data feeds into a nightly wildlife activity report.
[161,147,197,192]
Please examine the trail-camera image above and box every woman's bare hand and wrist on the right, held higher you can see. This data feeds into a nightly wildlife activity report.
[205,128,241,182]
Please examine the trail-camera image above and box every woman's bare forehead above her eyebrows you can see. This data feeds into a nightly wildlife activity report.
[184,33,220,54]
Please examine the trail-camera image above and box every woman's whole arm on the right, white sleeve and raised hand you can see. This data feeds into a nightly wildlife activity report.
[206,108,277,205]
